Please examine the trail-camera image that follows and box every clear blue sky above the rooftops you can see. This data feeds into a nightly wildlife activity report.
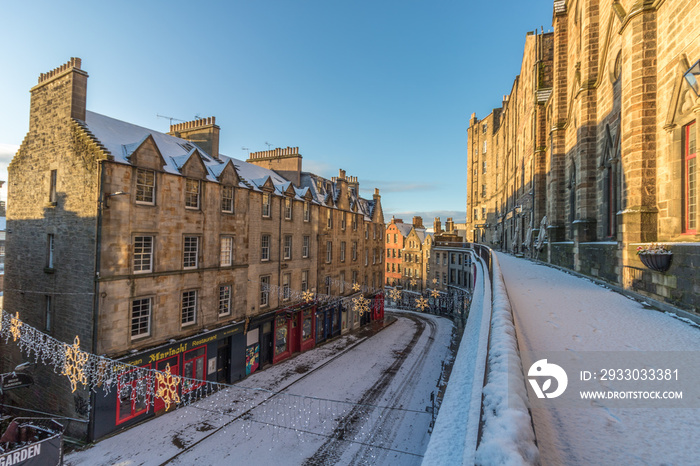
[0,0,552,225]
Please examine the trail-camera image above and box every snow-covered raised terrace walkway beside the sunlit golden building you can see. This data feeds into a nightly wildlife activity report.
[498,253,700,465]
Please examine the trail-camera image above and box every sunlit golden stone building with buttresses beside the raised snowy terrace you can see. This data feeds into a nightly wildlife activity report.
[467,0,700,312]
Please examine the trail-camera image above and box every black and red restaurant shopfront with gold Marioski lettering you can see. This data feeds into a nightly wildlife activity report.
[91,324,246,440]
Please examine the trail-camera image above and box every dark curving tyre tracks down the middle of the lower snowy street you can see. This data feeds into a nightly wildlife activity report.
[303,313,437,466]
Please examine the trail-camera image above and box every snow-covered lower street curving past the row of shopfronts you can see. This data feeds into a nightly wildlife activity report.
[65,310,453,466]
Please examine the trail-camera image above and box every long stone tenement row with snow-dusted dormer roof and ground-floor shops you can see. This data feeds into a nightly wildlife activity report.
[0,58,384,439]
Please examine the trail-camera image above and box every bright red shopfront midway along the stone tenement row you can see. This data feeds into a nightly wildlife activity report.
[272,303,316,364]
